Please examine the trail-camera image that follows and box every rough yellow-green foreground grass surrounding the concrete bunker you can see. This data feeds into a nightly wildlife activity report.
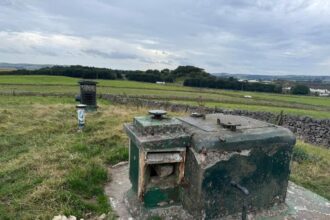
[0,96,330,219]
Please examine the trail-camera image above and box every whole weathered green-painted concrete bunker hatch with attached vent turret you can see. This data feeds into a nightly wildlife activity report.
[124,110,295,219]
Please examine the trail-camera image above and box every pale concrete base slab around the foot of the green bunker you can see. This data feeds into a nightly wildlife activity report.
[105,162,330,220]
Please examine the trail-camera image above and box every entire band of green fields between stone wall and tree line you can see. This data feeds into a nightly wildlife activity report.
[0,75,330,118]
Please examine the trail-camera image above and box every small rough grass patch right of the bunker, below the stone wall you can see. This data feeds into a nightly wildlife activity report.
[290,141,330,200]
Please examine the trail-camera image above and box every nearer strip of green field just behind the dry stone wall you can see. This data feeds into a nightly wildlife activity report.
[0,85,330,113]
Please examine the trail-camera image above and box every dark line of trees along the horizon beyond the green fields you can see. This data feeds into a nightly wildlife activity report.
[0,65,288,93]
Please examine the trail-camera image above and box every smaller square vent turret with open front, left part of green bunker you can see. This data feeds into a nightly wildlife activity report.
[124,110,190,208]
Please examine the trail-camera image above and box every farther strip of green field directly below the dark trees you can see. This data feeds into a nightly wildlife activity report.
[0,75,330,107]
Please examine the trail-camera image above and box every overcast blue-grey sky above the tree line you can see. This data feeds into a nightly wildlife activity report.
[0,0,330,75]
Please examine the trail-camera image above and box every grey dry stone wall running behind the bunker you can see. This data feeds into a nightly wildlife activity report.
[100,94,330,148]
